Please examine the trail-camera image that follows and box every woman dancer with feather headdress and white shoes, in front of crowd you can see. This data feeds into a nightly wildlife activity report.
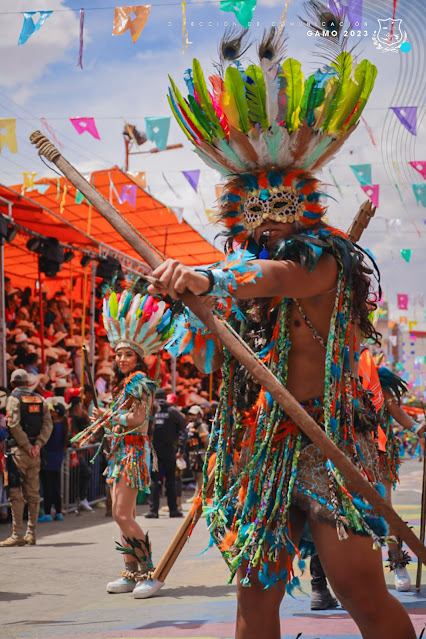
[73,291,171,598]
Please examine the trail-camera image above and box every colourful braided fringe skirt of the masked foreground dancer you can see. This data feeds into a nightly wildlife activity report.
[204,397,386,592]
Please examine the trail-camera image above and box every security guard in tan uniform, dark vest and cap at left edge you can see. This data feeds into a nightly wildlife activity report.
[0,368,53,548]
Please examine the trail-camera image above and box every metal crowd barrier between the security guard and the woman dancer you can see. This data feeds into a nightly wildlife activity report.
[61,444,106,512]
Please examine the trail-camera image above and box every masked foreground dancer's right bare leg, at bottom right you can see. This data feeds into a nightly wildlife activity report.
[308,518,416,639]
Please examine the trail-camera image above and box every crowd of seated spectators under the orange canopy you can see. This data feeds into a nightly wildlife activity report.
[0,278,220,521]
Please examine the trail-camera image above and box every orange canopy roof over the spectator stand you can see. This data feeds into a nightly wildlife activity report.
[0,167,222,288]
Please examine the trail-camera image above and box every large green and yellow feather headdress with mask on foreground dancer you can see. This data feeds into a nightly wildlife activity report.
[168,7,377,241]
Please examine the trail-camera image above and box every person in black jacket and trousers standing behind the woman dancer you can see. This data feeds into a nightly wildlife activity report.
[145,388,186,519]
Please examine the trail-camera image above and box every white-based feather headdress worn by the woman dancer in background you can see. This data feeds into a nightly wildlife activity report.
[103,290,173,357]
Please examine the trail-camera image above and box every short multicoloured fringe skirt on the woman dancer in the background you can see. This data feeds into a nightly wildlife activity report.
[107,433,151,494]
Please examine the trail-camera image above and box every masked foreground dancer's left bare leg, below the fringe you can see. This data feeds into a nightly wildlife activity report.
[235,508,305,639]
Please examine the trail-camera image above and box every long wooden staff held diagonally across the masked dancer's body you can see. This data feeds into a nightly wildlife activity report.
[30,131,426,564]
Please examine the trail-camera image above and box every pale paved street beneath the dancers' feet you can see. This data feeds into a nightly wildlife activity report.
[0,459,426,639]
